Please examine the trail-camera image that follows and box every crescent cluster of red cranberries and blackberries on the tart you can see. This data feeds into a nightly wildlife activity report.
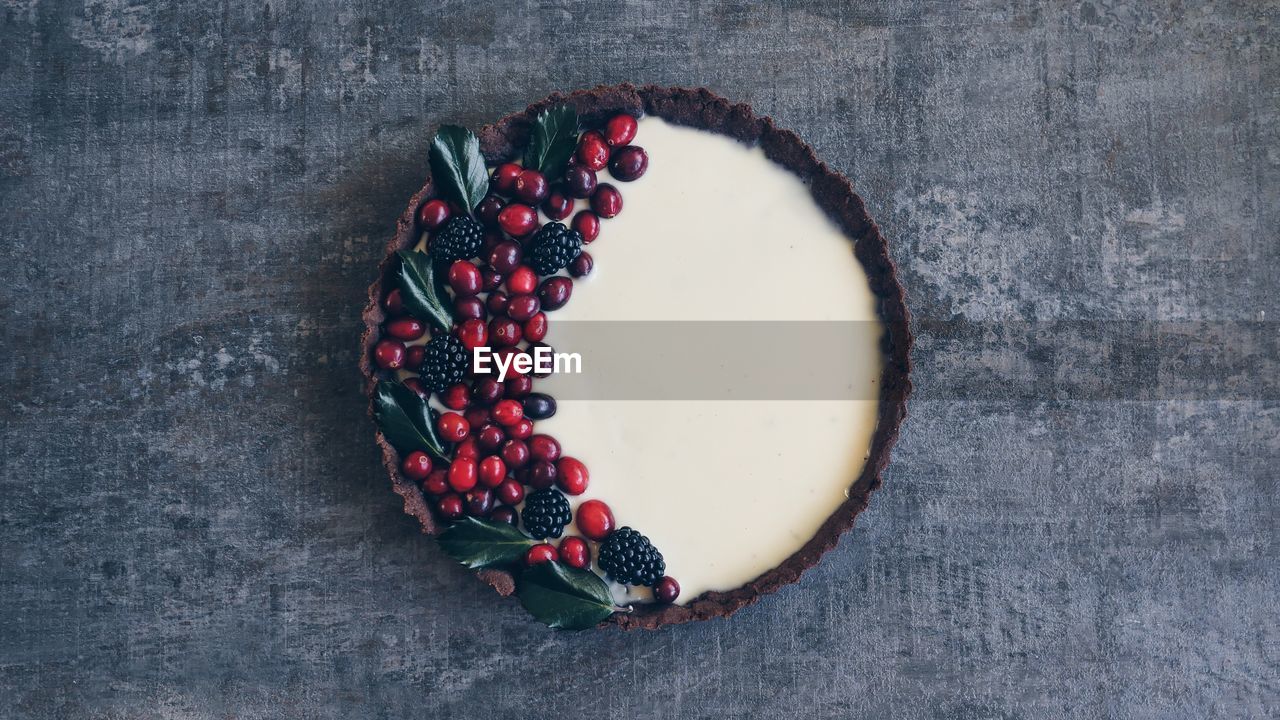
[374,114,678,602]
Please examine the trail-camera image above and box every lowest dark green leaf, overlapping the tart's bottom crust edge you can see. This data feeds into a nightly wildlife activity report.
[516,562,613,630]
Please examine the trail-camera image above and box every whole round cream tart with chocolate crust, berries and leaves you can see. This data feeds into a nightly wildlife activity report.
[361,85,911,629]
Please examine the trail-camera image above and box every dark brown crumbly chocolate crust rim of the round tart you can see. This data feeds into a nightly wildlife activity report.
[360,85,911,629]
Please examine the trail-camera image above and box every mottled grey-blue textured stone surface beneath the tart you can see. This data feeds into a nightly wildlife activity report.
[0,0,1280,719]
